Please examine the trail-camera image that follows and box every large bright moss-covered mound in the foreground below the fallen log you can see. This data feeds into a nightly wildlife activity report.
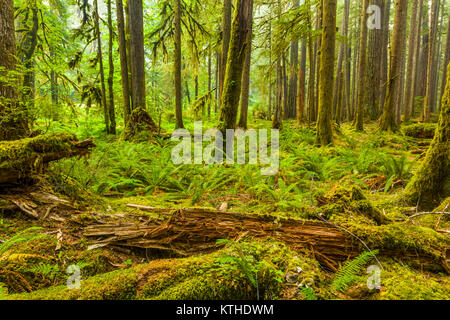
[2,242,323,300]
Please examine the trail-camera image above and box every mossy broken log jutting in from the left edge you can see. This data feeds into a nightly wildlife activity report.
[0,133,95,184]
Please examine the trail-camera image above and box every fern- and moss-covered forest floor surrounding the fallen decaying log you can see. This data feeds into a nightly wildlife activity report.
[0,121,450,299]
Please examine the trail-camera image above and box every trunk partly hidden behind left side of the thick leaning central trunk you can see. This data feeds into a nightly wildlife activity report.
[219,0,232,108]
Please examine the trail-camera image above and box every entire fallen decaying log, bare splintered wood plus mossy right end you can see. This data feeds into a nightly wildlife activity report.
[84,209,450,271]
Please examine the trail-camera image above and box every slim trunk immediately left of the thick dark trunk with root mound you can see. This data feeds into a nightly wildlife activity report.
[116,0,132,131]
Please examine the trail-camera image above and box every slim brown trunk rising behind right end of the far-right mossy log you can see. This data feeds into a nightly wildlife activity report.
[423,0,440,122]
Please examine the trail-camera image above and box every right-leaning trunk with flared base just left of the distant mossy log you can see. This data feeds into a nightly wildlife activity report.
[380,0,408,131]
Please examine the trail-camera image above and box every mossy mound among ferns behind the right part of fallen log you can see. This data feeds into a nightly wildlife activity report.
[317,186,389,225]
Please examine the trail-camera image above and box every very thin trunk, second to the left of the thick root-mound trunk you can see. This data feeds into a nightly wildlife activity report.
[107,0,116,134]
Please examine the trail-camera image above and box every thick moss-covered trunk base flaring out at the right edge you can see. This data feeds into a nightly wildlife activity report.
[404,65,450,208]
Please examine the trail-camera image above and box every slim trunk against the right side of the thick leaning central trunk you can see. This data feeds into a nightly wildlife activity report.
[238,1,253,129]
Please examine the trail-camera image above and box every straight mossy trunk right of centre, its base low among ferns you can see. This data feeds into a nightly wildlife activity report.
[317,0,337,146]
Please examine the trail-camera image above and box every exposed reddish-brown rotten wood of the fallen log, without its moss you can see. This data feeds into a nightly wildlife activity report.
[84,209,448,271]
